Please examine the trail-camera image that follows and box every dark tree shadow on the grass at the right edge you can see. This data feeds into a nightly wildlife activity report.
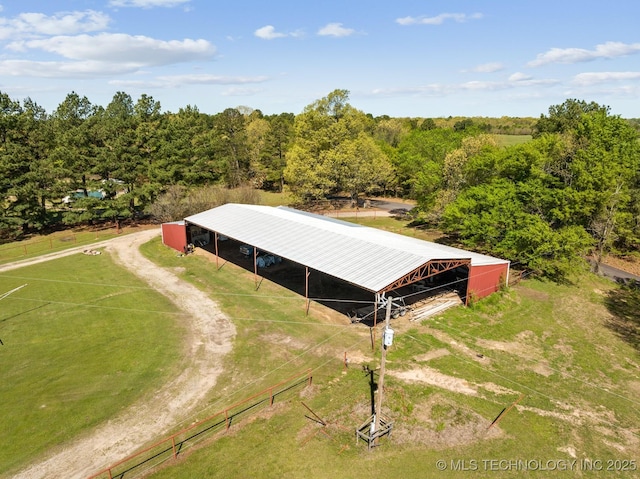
[605,281,640,353]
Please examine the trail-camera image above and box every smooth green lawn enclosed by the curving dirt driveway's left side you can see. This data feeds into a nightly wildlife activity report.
[0,255,182,474]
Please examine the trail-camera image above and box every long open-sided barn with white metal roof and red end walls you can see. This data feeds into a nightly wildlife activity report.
[162,203,509,322]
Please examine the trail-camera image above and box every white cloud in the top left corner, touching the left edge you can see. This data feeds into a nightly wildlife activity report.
[0,10,110,40]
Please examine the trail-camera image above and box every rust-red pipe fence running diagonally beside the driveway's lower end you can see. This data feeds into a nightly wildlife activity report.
[88,369,313,479]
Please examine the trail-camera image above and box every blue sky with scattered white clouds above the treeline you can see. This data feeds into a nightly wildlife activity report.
[0,0,640,118]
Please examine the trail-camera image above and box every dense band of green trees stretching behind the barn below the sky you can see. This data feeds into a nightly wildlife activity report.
[0,90,640,278]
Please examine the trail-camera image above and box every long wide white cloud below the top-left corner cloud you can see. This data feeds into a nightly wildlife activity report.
[7,33,216,66]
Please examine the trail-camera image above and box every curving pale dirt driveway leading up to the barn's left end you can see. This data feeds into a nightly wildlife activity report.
[6,229,235,479]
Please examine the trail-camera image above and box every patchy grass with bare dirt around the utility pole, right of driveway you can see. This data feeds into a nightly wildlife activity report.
[141,232,640,478]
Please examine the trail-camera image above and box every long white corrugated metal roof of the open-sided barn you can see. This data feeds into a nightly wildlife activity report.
[185,203,508,292]
